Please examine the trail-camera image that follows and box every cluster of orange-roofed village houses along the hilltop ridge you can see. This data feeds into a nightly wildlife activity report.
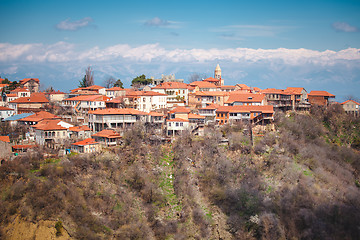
[0,65,359,159]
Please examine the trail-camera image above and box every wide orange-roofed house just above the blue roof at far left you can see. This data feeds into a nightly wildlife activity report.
[9,93,49,114]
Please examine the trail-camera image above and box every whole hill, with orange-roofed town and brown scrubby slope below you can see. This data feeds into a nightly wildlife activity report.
[0,65,360,240]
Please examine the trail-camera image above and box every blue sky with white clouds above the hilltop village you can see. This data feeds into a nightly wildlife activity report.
[0,0,360,101]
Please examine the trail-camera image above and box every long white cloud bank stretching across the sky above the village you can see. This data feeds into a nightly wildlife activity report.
[0,42,360,65]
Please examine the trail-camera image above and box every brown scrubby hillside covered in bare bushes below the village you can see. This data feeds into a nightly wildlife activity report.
[0,106,360,239]
